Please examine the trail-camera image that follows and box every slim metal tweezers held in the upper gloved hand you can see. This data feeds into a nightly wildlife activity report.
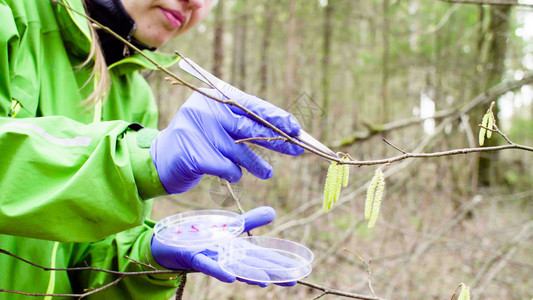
[179,57,337,157]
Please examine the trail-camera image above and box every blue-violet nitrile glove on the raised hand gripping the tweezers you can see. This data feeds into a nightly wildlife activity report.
[150,89,304,194]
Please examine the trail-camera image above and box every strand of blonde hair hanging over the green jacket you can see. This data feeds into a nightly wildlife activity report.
[79,0,111,108]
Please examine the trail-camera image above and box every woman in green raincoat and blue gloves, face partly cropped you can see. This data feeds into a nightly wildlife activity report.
[0,0,303,299]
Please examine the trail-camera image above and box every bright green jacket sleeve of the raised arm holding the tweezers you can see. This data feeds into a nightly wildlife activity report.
[0,0,166,242]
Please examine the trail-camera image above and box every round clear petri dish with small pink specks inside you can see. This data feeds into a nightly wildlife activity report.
[154,210,244,248]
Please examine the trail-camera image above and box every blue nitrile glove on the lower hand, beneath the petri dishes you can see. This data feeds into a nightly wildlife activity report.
[151,206,296,287]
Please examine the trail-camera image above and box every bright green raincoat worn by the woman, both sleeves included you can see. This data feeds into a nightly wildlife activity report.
[0,0,183,300]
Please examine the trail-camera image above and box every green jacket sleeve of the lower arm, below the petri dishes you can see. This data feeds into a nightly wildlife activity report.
[69,222,181,300]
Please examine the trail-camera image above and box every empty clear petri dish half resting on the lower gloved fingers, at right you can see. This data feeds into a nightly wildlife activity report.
[218,236,314,283]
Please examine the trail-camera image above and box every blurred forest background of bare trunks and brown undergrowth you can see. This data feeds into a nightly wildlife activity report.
[145,0,533,299]
